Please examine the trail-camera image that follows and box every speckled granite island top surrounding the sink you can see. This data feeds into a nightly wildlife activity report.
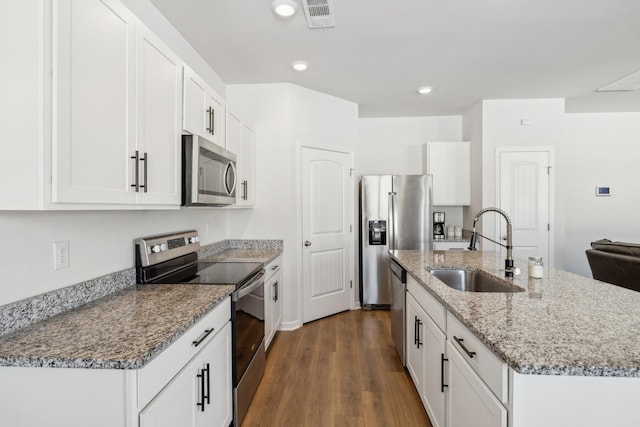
[391,250,640,377]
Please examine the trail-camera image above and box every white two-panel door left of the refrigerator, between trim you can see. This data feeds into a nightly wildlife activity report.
[302,147,354,322]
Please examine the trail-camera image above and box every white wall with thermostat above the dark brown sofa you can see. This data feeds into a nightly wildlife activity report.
[556,113,640,277]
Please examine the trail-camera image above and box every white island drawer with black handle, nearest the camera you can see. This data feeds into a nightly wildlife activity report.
[447,313,509,403]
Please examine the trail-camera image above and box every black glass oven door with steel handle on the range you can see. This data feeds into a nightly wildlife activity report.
[233,270,264,386]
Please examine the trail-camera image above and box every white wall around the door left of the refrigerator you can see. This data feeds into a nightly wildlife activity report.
[227,84,358,329]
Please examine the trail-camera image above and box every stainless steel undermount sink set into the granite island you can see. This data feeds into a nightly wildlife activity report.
[427,268,524,292]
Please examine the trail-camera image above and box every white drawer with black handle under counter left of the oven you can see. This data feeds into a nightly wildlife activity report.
[138,297,231,409]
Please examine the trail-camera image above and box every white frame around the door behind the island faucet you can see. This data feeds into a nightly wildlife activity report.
[494,145,556,267]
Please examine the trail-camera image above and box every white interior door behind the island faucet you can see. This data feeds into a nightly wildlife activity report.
[498,149,551,265]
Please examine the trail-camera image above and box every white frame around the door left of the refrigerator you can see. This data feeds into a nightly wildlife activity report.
[296,139,359,326]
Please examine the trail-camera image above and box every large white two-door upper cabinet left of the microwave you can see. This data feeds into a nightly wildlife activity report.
[0,0,188,210]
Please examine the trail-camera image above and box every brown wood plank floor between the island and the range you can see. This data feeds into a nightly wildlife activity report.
[242,310,431,427]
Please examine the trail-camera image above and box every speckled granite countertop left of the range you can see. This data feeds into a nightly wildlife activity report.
[0,284,234,369]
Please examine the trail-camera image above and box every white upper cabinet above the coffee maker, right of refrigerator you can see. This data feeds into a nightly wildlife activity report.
[424,142,471,206]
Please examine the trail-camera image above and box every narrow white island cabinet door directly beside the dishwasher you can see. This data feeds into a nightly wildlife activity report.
[405,292,427,394]
